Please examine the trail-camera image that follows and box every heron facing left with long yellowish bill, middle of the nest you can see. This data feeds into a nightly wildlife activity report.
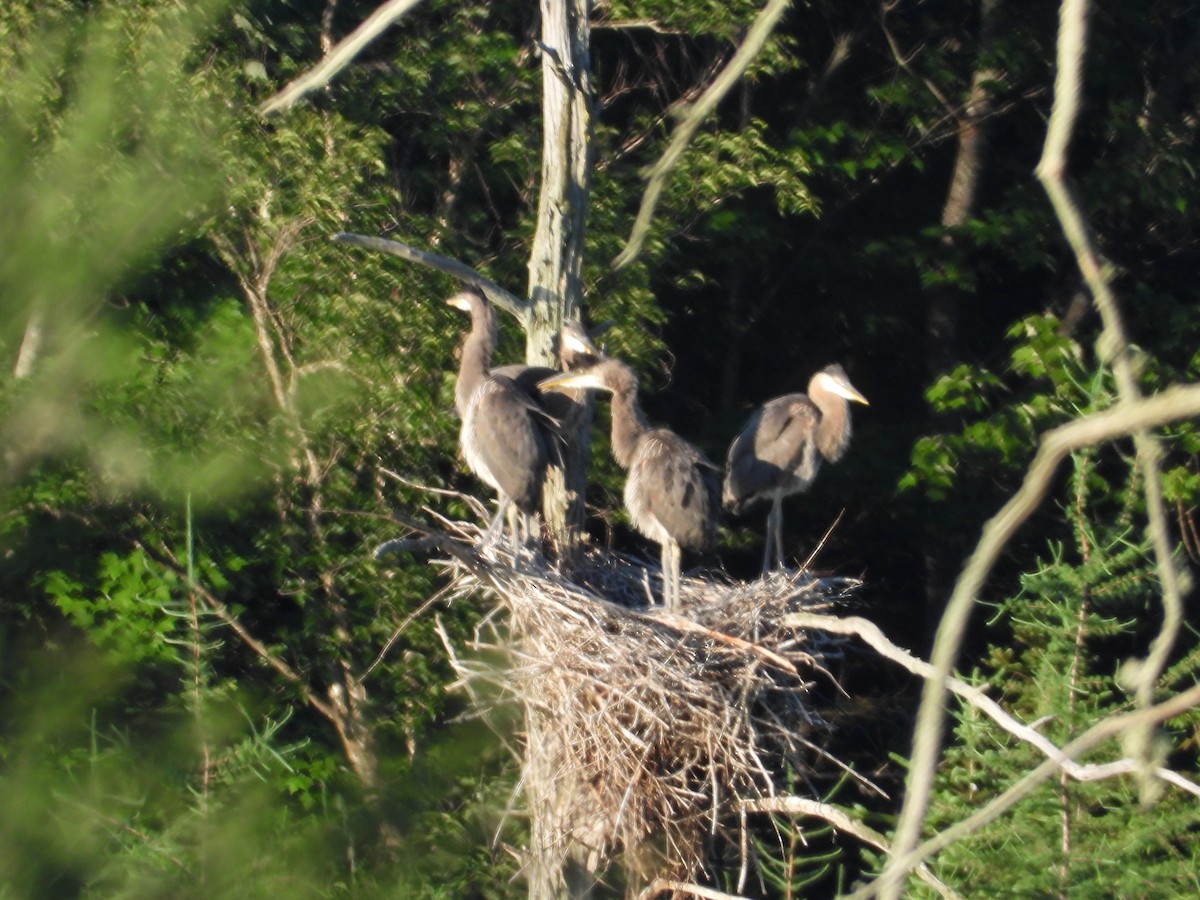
[542,359,720,611]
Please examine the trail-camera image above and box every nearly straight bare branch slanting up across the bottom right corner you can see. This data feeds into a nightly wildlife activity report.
[847,684,1200,900]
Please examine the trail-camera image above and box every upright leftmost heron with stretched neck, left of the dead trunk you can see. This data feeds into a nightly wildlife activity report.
[446,290,551,542]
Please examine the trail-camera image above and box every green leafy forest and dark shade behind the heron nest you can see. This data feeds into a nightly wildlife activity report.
[0,0,1200,896]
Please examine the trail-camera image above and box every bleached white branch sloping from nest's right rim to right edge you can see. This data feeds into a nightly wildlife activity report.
[780,612,1200,797]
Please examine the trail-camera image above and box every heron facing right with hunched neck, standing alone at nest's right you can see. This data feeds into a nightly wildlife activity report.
[722,365,866,575]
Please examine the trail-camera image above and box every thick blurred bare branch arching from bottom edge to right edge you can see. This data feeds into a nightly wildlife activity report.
[872,384,1200,896]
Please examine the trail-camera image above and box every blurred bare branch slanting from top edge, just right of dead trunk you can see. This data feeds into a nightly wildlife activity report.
[612,0,791,269]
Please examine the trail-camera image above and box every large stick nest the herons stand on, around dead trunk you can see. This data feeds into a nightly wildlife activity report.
[398,523,857,892]
